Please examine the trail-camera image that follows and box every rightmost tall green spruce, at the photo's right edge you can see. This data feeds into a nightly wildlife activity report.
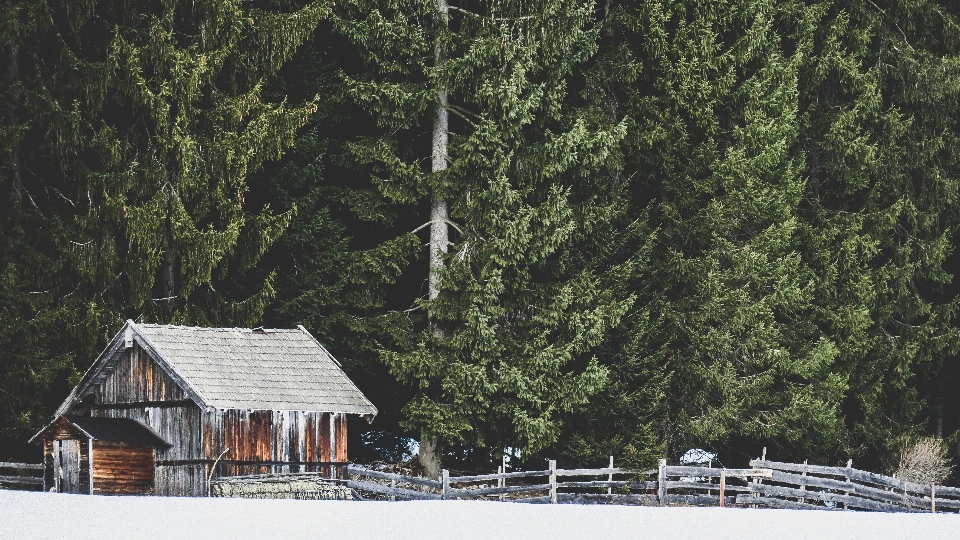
[797,1,960,464]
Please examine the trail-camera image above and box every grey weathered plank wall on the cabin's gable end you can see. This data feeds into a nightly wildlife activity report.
[91,343,206,496]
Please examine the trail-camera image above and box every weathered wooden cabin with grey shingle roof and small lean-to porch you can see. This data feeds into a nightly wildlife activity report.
[31,321,377,496]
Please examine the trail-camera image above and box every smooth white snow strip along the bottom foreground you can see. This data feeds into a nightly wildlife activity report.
[0,490,960,540]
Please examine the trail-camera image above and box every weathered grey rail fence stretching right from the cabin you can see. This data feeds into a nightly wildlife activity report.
[345,459,960,512]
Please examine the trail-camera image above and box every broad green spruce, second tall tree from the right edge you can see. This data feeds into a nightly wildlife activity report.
[565,0,846,460]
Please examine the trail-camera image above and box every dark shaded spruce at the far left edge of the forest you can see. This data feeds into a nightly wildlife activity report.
[0,1,75,461]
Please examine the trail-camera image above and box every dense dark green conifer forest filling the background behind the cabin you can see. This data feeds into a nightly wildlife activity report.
[0,0,960,476]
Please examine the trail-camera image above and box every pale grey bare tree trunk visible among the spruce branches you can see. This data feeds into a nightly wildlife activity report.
[418,0,449,478]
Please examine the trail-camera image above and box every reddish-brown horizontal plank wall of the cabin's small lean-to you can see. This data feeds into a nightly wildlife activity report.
[93,441,154,495]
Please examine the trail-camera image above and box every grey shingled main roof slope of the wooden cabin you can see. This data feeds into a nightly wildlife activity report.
[128,322,377,415]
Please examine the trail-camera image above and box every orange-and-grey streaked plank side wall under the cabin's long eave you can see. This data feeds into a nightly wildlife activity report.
[203,409,347,476]
